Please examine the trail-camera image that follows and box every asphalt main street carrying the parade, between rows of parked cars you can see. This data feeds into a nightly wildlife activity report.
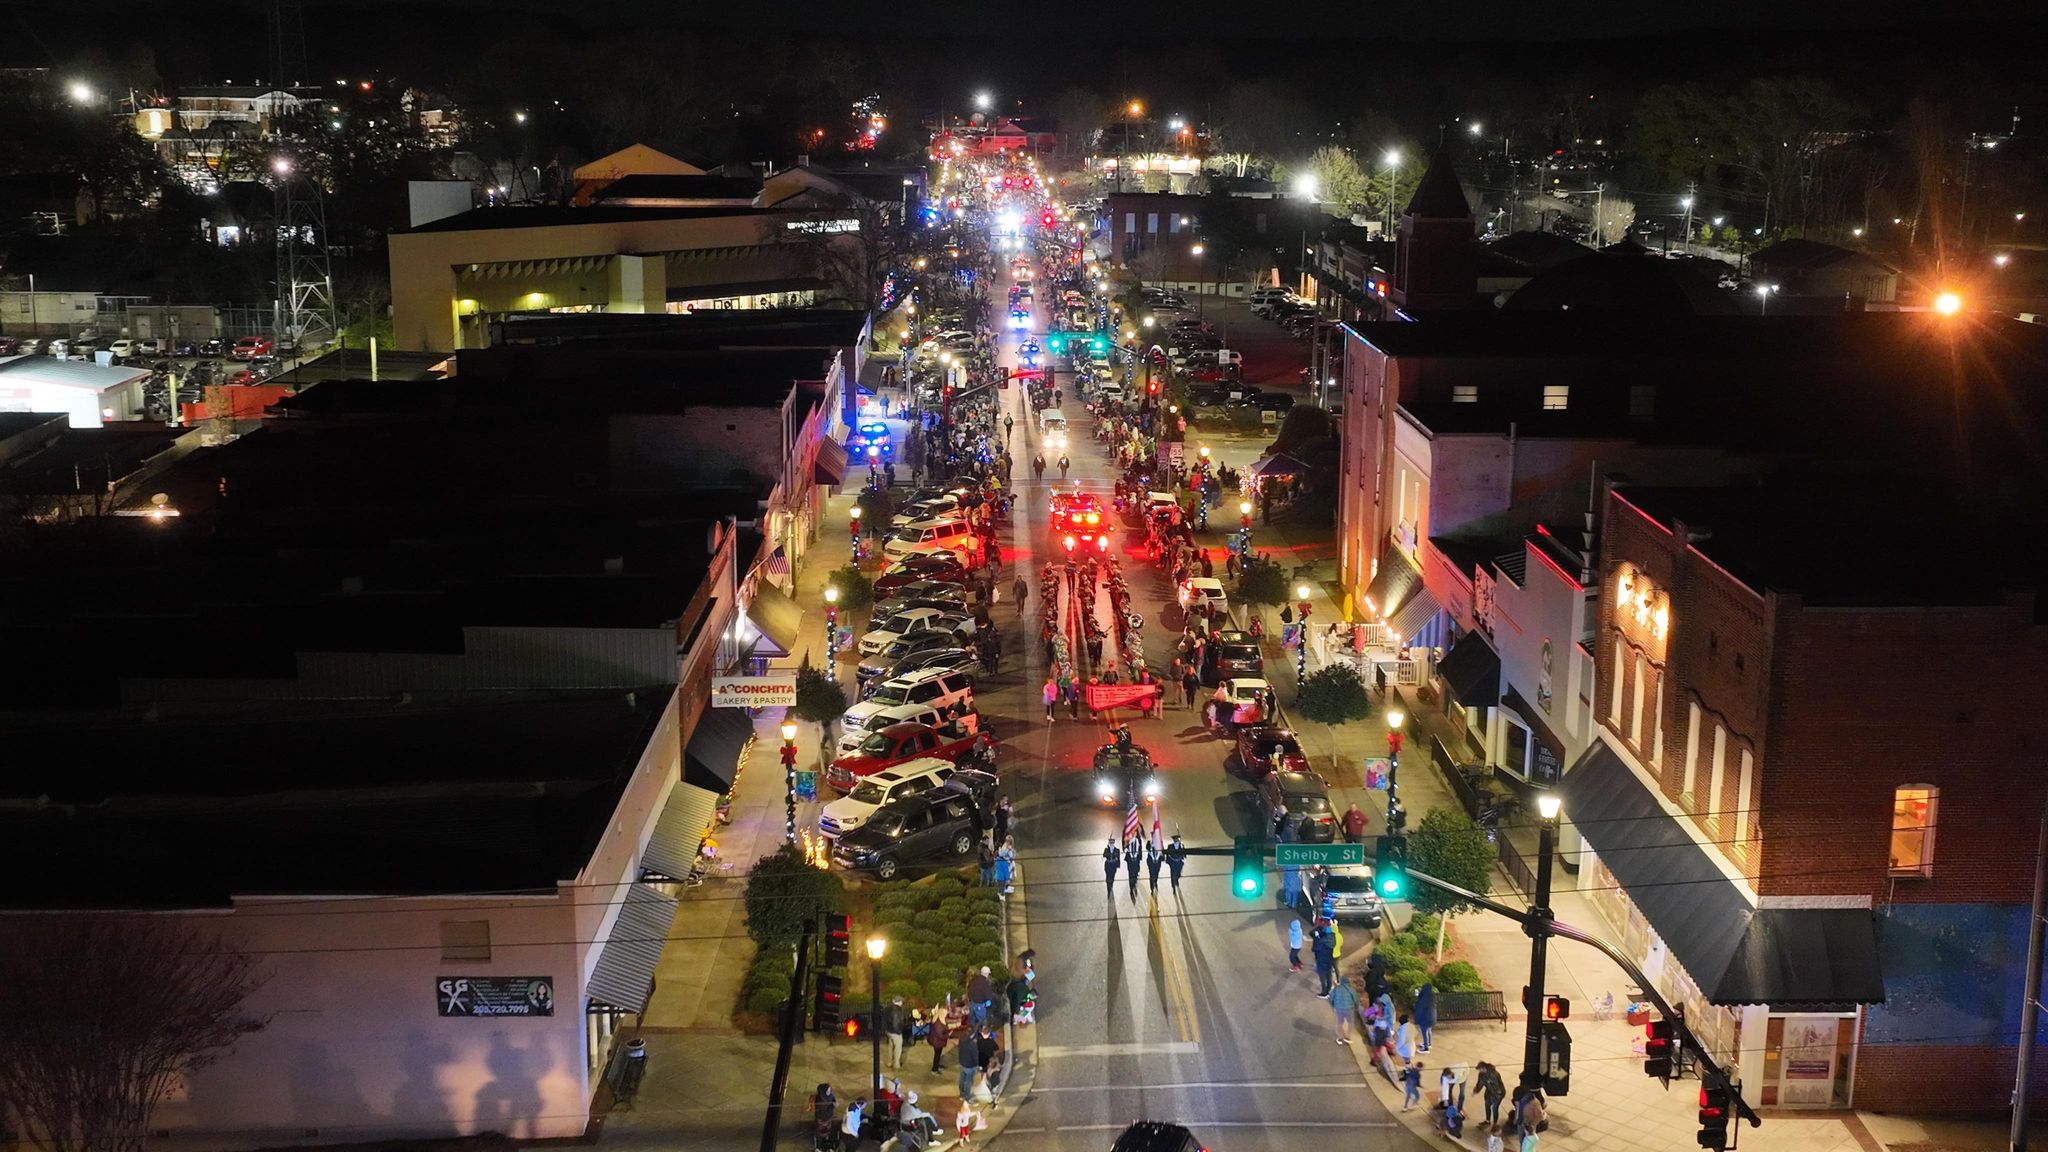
[977,243,1423,1152]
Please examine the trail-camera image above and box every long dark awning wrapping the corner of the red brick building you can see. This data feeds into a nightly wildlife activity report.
[1565,740,1884,1006]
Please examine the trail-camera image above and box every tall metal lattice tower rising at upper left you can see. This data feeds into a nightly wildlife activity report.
[268,0,336,351]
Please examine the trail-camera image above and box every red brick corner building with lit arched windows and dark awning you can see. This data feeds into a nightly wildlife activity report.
[1565,482,2048,1111]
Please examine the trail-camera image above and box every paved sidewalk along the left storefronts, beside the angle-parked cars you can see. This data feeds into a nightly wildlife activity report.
[596,477,1036,1152]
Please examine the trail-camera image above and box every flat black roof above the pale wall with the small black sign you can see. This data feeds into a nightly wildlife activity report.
[0,685,672,908]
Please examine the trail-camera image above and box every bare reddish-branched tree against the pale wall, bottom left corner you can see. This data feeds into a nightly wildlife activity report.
[0,914,266,1152]
